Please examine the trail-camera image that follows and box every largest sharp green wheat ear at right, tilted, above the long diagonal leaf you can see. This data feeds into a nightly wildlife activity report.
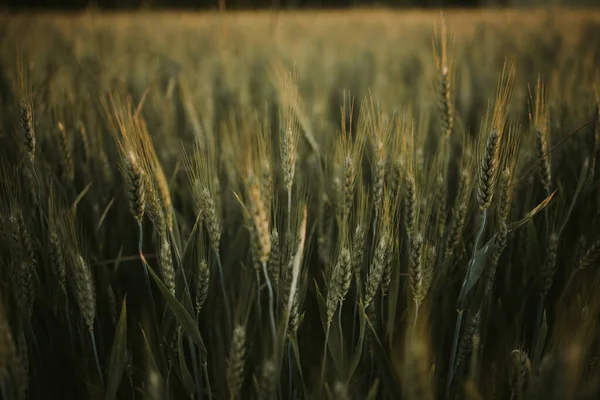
[477,130,500,211]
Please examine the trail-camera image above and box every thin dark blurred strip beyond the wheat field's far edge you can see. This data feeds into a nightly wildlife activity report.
[0,0,600,10]
